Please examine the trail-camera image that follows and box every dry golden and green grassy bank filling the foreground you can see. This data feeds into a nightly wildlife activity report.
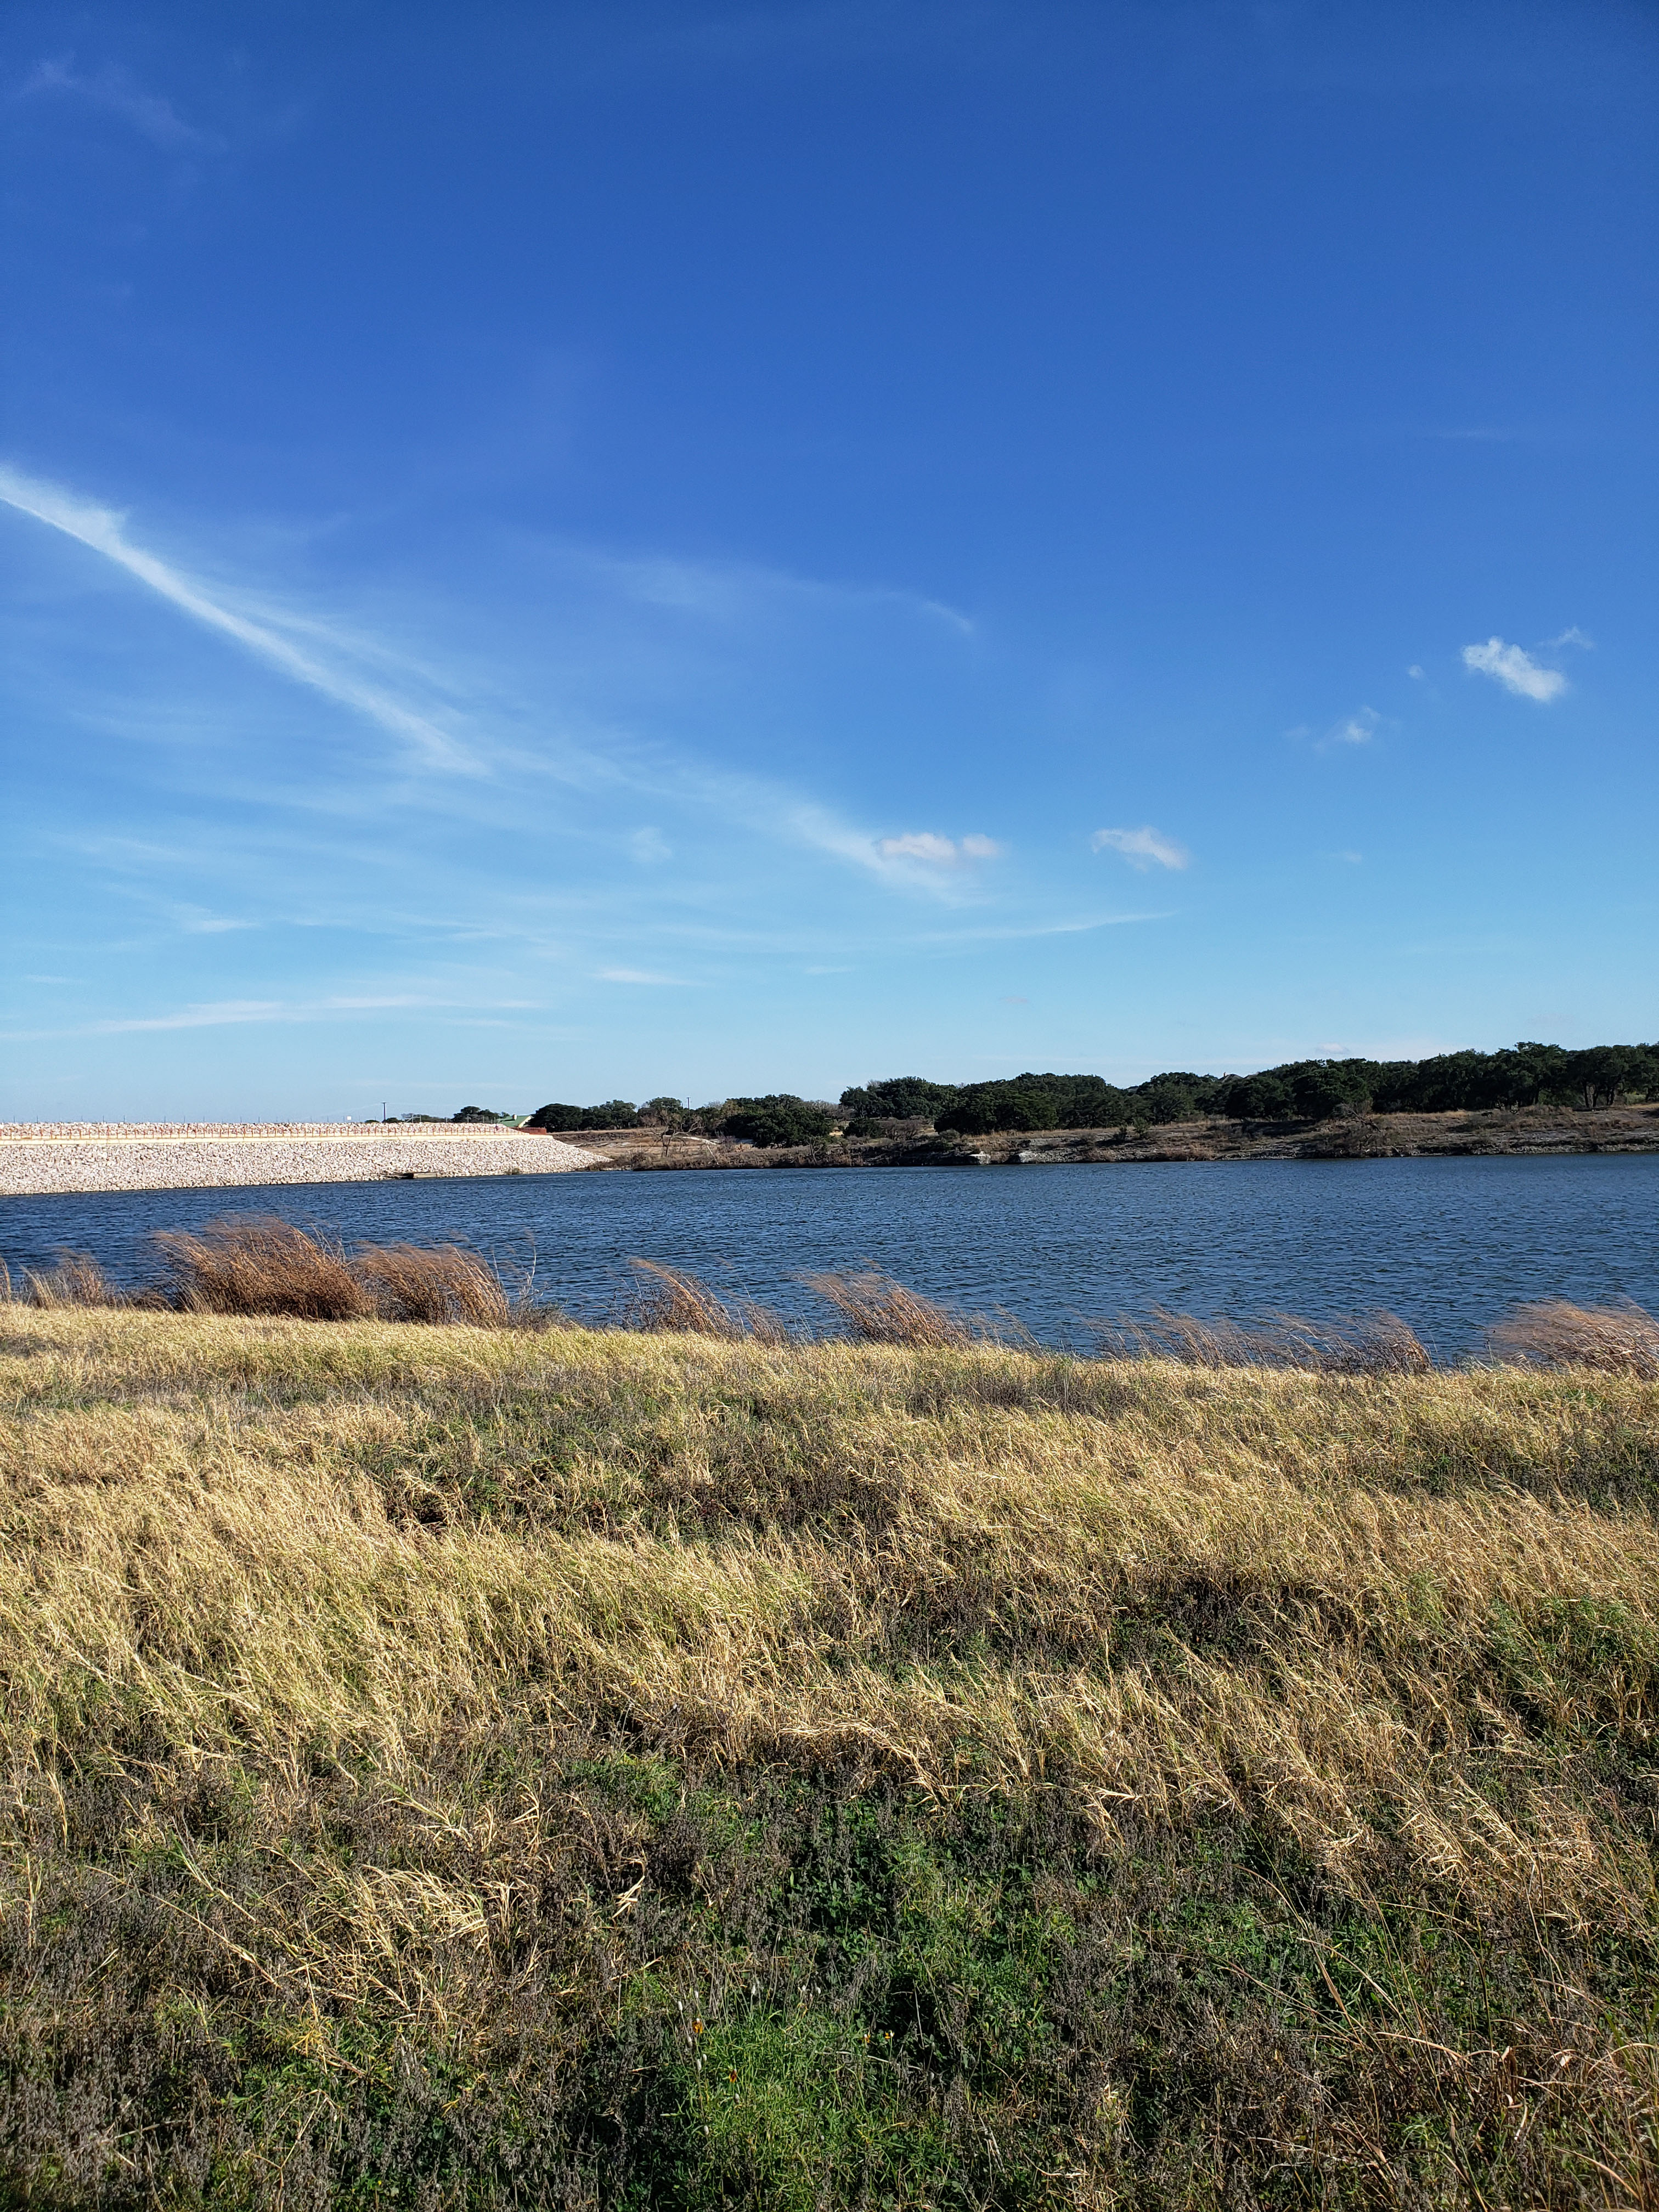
[0,1307,1659,2208]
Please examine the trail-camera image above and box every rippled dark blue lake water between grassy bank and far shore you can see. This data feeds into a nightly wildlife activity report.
[0,1157,1659,1356]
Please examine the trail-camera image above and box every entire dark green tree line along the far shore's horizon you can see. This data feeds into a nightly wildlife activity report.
[517,1042,1659,1146]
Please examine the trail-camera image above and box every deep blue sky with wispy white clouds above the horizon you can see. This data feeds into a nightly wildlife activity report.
[0,0,1659,1117]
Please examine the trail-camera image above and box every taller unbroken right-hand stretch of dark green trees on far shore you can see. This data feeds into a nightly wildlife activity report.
[840,1044,1659,1137]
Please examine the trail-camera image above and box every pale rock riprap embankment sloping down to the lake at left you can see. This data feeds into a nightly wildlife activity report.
[0,1121,597,1199]
